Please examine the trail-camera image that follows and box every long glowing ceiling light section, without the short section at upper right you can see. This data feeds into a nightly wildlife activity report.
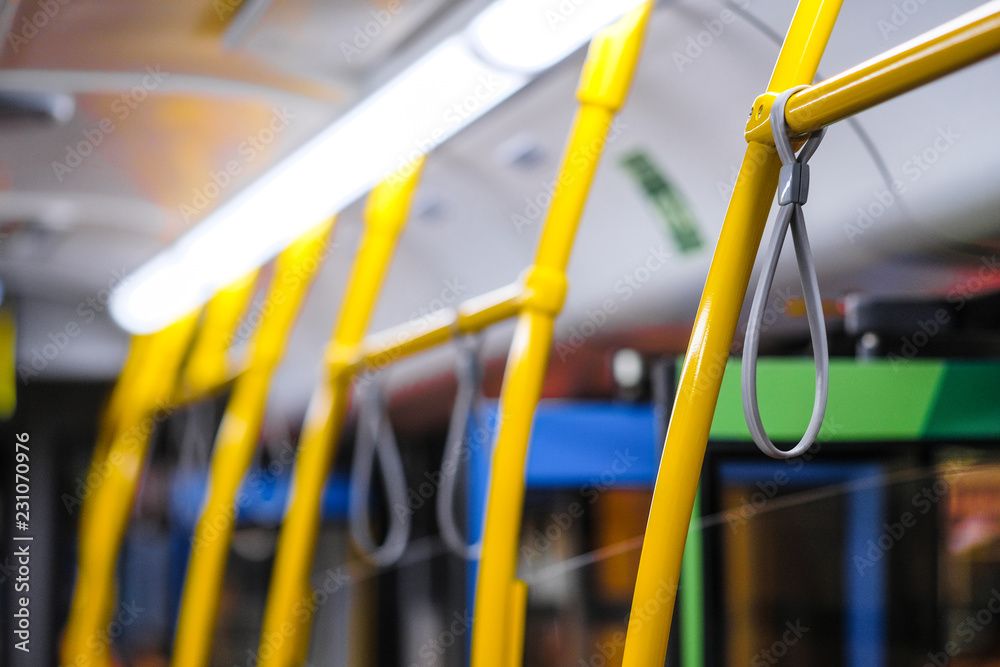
[111,37,526,334]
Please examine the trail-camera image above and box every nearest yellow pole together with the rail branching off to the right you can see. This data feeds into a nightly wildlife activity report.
[622,0,1000,667]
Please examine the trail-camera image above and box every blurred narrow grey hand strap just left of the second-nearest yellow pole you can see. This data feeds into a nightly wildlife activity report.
[436,336,483,560]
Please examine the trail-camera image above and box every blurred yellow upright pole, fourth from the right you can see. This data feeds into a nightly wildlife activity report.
[171,219,333,667]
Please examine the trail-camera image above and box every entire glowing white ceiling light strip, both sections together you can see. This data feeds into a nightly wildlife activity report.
[110,0,638,334]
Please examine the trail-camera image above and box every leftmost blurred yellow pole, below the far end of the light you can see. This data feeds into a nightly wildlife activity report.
[61,314,197,667]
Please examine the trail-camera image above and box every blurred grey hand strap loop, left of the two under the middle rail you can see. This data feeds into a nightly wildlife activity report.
[348,376,411,567]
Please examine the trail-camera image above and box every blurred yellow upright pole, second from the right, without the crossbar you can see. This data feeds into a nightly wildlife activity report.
[472,2,652,667]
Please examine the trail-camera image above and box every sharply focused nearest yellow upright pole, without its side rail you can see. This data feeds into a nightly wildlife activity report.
[622,0,842,667]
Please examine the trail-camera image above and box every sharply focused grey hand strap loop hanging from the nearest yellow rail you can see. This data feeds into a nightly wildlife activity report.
[742,86,830,459]
